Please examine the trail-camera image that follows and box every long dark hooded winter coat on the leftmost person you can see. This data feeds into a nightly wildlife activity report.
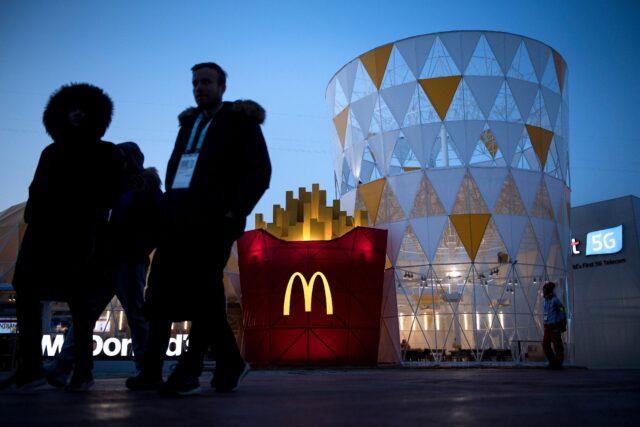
[13,84,124,300]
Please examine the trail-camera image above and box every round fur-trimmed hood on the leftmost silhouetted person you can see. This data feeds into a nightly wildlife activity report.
[42,83,113,142]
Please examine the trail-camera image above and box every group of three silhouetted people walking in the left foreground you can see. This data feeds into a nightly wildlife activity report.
[0,62,271,397]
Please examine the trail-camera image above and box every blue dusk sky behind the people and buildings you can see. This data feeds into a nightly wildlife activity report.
[0,0,640,224]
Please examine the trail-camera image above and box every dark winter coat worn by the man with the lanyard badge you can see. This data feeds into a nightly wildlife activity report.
[146,102,271,320]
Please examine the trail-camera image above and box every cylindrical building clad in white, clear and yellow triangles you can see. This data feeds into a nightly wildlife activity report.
[326,31,570,361]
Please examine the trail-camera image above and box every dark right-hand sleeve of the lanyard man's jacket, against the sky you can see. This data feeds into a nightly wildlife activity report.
[228,119,271,217]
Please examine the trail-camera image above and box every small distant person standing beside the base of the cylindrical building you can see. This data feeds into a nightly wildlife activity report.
[542,282,567,370]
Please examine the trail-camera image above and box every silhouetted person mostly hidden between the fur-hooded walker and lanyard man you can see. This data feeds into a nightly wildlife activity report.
[47,142,162,387]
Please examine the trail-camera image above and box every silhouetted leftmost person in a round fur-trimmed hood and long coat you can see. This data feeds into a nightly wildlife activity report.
[0,83,124,391]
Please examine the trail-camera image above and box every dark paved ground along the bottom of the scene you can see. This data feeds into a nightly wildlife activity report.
[0,368,640,427]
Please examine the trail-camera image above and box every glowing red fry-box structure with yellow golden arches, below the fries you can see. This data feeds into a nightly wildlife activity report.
[238,227,388,366]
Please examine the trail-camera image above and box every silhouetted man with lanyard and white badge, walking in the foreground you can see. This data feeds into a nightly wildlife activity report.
[126,62,271,397]
